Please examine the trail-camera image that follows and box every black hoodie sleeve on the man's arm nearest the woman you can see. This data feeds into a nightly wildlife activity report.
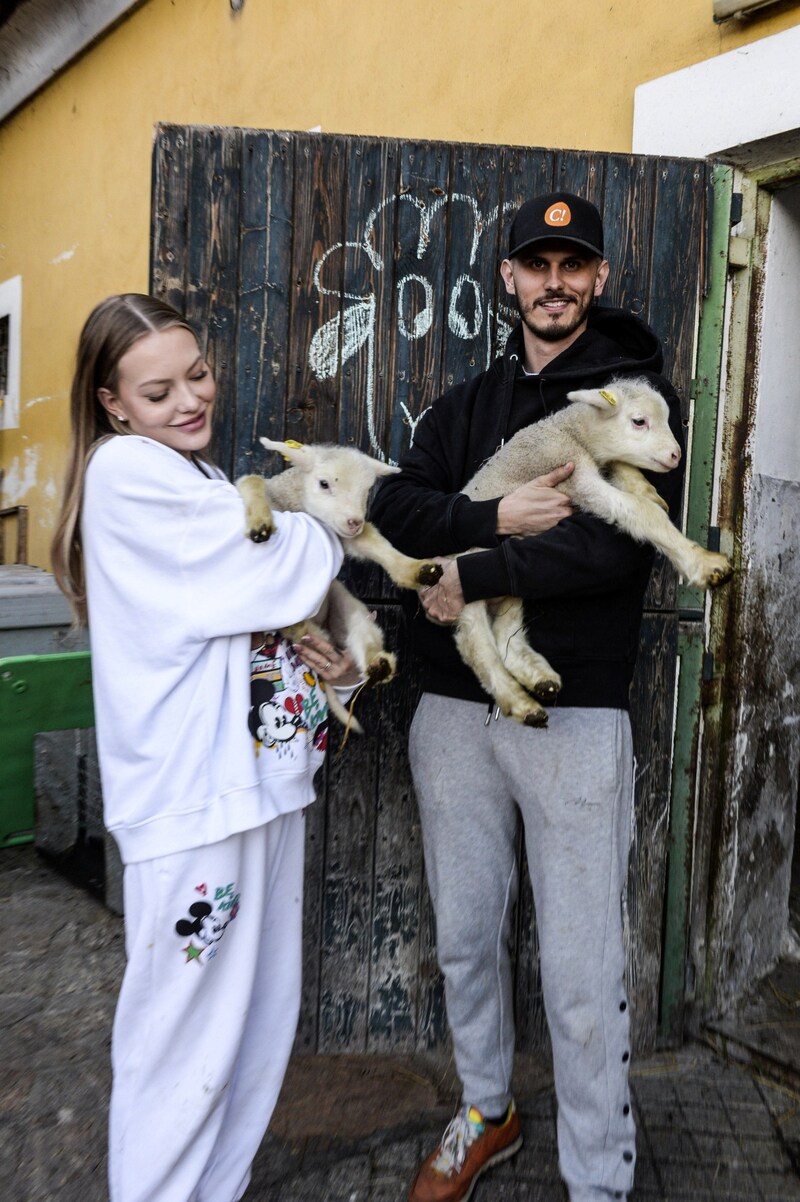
[370,381,500,558]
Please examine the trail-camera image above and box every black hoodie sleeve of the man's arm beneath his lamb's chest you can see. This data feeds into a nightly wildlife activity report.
[459,380,683,601]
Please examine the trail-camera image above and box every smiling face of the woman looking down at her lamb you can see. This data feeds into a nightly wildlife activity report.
[97,326,216,457]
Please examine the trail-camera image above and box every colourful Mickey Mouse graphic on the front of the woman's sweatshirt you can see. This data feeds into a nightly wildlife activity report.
[247,633,328,758]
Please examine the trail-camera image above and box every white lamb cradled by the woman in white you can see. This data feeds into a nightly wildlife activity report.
[237,439,442,732]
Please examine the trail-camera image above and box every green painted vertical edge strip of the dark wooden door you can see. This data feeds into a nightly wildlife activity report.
[659,163,733,1043]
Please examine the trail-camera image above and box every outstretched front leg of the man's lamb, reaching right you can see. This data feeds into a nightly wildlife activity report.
[571,469,733,589]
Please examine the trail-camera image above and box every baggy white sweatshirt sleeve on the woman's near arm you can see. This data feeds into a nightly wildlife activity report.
[83,435,342,641]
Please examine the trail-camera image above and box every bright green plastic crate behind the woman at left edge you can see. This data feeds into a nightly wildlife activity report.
[0,651,95,847]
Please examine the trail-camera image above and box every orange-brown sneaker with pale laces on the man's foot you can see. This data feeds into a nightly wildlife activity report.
[408,1102,523,1202]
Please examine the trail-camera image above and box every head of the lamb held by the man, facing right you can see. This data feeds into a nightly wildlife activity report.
[569,380,681,471]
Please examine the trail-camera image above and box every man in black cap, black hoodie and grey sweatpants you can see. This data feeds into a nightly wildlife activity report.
[372,192,682,1202]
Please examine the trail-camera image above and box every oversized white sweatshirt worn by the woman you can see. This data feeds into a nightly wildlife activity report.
[82,434,342,863]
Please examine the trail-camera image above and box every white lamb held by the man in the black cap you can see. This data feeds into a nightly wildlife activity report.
[455,379,732,726]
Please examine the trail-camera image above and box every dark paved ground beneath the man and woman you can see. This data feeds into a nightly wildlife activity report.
[0,847,800,1202]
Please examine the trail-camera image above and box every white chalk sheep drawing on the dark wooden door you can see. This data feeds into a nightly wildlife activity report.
[309,192,517,459]
